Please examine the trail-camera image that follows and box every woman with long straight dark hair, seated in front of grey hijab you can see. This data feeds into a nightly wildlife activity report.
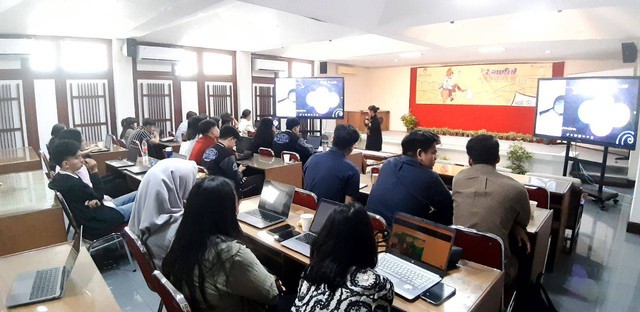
[162,177,280,312]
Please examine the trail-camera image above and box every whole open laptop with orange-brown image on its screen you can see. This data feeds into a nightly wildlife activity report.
[376,212,456,300]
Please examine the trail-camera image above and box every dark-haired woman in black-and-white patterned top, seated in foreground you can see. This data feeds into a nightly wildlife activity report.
[291,205,394,312]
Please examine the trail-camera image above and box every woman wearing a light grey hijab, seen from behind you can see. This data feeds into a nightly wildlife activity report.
[129,158,198,268]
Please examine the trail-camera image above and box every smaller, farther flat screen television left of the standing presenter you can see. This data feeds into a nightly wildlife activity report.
[276,77,344,119]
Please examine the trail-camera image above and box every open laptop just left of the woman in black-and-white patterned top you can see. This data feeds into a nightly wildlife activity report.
[281,198,342,257]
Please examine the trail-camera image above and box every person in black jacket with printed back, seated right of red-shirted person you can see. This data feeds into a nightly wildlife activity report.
[202,125,245,191]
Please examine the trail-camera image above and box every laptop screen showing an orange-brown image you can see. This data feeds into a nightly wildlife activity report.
[387,213,455,271]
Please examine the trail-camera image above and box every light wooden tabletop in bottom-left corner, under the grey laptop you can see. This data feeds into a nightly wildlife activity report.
[0,243,121,312]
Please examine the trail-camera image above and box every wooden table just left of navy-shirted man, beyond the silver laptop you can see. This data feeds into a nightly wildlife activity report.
[238,154,302,188]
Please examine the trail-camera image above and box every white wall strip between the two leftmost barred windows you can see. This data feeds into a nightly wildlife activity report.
[33,79,58,152]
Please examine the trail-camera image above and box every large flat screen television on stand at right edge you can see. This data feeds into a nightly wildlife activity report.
[534,77,640,150]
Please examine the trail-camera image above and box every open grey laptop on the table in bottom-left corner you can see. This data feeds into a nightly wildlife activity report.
[7,232,82,308]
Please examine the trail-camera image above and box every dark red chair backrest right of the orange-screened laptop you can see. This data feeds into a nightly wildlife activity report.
[452,225,504,271]
